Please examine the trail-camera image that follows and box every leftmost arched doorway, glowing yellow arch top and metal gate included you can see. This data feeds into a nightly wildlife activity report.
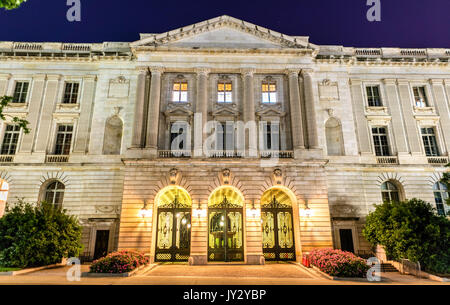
[155,187,192,262]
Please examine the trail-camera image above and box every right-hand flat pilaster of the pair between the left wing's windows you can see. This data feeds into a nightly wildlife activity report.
[35,75,61,153]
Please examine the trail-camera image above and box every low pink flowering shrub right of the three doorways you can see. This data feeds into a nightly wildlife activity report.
[308,249,370,277]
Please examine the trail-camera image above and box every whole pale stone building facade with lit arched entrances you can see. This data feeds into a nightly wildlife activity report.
[0,16,450,264]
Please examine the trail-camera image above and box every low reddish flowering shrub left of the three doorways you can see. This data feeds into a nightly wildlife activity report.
[90,250,149,273]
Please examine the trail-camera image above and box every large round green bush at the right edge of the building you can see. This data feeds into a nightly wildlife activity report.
[363,198,450,273]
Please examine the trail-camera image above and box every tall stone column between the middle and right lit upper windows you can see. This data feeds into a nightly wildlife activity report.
[242,69,258,157]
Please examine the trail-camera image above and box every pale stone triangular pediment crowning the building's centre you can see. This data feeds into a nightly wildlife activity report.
[131,16,316,49]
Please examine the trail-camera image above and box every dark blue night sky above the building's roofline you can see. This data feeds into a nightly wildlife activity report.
[0,0,450,48]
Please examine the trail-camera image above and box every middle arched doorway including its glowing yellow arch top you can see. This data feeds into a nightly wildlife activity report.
[208,187,244,262]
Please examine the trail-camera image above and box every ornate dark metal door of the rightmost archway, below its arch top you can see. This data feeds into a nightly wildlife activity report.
[261,196,295,261]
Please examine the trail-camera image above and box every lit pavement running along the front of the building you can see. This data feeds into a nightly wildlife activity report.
[0,263,444,285]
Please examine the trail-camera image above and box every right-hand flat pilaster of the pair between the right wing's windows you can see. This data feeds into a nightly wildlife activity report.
[397,79,422,155]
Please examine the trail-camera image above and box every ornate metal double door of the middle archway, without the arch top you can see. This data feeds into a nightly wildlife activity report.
[208,196,244,262]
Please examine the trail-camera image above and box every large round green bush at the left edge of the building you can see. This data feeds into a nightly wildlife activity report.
[0,200,83,268]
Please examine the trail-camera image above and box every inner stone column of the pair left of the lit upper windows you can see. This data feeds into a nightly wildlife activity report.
[145,67,163,151]
